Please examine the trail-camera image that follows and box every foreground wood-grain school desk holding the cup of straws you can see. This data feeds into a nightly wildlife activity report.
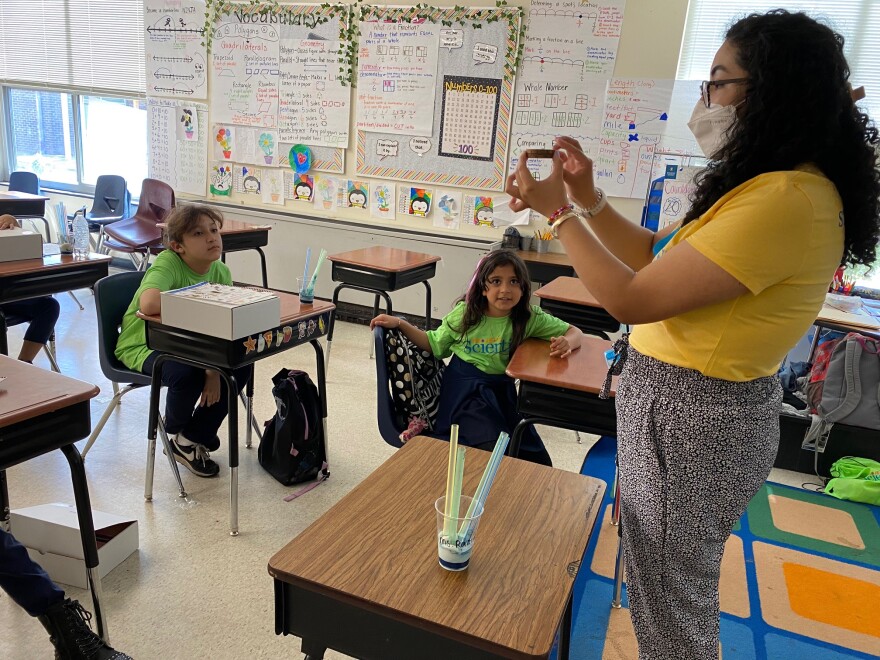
[269,437,605,660]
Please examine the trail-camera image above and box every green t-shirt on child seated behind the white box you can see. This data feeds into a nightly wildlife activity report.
[116,250,232,371]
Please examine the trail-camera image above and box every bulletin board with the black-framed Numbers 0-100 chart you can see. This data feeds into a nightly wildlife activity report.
[356,7,519,190]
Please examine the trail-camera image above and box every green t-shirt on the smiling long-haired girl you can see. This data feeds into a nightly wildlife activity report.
[428,302,569,374]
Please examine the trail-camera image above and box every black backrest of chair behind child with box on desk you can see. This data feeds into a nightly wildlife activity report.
[95,272,150,385]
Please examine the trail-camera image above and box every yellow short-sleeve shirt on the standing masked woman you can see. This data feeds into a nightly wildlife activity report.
[630,167,843,381]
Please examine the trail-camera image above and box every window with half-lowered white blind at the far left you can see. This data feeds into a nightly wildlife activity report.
[0,0,147,193]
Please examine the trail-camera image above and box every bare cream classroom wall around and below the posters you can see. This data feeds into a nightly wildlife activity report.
[6,0,688,318]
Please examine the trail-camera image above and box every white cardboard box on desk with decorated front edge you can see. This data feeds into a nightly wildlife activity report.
[161,282,281,339]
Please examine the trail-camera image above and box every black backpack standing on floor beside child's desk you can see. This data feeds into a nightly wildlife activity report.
[257,369,330,486]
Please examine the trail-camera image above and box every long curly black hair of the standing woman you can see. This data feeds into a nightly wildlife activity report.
[684,9,880,266]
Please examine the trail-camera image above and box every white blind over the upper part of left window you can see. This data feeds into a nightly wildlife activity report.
[0,0,145,97]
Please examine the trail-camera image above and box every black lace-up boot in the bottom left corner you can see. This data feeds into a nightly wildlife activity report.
[37,598,131,660]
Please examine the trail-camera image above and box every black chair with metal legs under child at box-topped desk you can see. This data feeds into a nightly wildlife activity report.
[81,272,186,497]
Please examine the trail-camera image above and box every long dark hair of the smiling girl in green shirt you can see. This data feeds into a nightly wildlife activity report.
[453,250,532,355]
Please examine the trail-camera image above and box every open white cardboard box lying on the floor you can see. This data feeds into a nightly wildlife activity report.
[9,502,138,589]
